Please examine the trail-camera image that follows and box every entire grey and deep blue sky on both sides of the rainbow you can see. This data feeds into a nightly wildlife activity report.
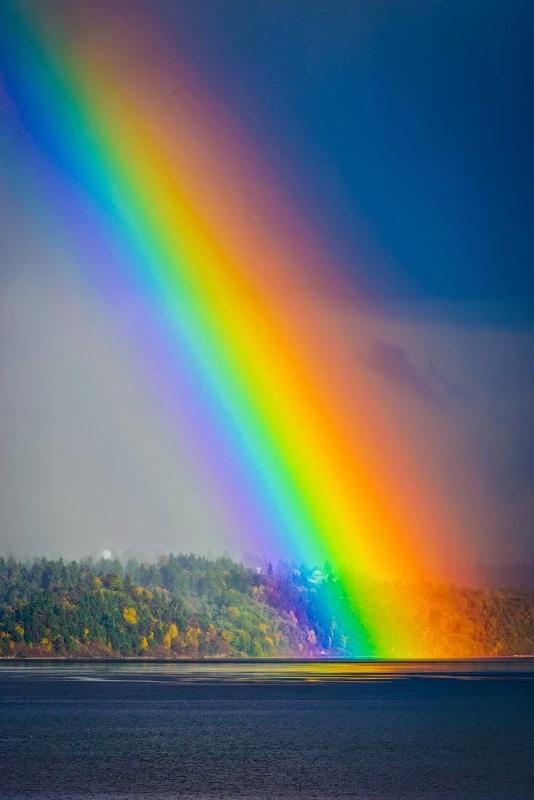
[0,0,534,570]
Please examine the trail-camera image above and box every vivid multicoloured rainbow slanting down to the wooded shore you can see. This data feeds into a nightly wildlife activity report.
[0,2,468,657]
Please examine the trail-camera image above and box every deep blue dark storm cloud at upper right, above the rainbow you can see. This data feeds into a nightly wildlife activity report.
[162,0,534,328]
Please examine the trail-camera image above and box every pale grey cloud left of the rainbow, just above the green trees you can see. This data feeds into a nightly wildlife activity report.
[0,275,239,557]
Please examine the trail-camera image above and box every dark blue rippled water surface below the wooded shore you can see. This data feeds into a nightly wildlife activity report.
[0,659,534,800]
